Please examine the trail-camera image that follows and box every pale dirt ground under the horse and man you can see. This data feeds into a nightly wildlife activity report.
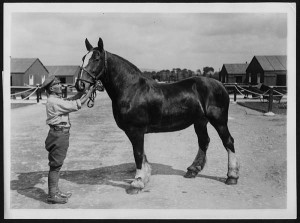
[10,92,287,215]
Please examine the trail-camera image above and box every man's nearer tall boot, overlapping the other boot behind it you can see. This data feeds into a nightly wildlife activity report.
[47,167,68,204]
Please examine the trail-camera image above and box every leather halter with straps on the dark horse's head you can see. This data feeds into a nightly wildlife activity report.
[76,50,107,108]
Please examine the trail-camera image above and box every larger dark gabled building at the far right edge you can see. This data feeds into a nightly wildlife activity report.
[246,55,287,86]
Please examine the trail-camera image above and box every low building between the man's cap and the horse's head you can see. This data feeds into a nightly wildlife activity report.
[46,66,80,85]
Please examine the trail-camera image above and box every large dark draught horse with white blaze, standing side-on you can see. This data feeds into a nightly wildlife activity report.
[75,38,239,189]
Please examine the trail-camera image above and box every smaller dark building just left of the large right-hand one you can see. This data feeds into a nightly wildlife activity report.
[219,63,248,83]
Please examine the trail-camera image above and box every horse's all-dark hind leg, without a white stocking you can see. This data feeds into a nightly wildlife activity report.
[184,120,210,178]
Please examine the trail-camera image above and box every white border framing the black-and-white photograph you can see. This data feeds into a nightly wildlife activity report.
[2,3,297,219]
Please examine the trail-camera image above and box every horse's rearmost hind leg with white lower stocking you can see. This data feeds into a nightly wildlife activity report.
[212,123,239,184]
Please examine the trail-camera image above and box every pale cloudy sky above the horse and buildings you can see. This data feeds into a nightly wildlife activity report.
[10,4,287,71]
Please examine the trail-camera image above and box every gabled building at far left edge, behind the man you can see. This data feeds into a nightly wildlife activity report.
[10,58,49,86]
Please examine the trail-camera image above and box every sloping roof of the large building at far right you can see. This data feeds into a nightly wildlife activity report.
[254,55,287,71]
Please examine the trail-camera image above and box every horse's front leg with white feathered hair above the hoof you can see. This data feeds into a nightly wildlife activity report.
[126,129,151,189]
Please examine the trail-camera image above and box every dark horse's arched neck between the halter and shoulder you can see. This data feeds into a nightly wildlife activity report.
[102,52,141,101]
